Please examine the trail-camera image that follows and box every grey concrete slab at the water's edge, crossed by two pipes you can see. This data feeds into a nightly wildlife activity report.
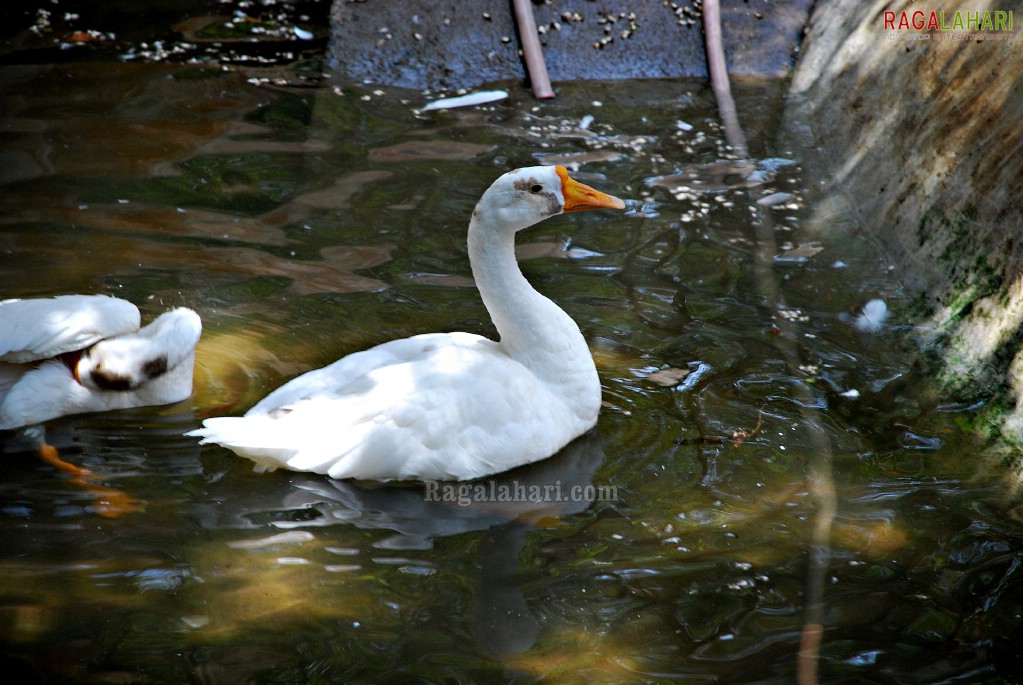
[328,0,812,90]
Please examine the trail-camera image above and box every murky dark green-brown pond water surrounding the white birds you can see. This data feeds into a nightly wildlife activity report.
[0,18,1023,683]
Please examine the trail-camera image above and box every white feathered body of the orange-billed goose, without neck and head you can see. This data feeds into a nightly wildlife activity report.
[191,333,595,481]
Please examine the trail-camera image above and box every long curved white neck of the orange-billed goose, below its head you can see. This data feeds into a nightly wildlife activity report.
[469,209,595,378]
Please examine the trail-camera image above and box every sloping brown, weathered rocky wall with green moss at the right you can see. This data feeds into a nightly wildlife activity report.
[791,0,1023,445]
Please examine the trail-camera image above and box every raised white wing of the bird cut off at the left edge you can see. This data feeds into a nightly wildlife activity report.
[0,294,141,363]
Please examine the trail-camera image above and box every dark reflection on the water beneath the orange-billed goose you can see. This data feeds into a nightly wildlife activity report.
[201,429,615,657]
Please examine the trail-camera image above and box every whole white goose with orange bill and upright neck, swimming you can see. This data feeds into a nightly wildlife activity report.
[188,167,625,481]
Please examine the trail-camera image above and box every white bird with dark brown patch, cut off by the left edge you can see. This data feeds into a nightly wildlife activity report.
[0,294,202,429]
